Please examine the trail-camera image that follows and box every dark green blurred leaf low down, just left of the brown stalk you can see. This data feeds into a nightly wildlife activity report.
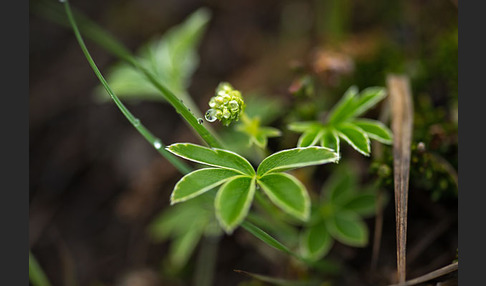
[300,165,376,260]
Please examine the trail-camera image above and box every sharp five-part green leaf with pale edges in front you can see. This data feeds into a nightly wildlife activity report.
[167,143,339,233]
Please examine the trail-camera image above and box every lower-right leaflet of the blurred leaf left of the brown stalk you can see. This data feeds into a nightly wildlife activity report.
[326,211,368,247]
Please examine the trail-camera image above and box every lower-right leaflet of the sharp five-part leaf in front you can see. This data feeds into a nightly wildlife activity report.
[258,173,310,221]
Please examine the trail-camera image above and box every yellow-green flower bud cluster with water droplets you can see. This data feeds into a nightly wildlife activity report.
[204,82,245,126]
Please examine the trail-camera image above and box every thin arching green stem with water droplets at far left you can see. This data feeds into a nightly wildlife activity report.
[64,0,191,174]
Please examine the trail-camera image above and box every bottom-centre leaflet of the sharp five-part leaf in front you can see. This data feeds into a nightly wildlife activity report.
[215,177,255,233]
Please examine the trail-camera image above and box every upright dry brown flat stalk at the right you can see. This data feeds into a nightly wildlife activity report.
[387,75,413,283]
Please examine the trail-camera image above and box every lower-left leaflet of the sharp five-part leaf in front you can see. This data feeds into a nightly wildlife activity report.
[170,168,241,205]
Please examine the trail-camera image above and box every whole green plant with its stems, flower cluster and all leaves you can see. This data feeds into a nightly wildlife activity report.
[53,1,393,284]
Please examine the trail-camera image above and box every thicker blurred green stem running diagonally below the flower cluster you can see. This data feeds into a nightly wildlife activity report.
[55,0,223,148]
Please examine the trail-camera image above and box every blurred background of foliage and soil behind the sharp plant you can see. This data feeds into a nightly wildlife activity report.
[29,0,458,286]
